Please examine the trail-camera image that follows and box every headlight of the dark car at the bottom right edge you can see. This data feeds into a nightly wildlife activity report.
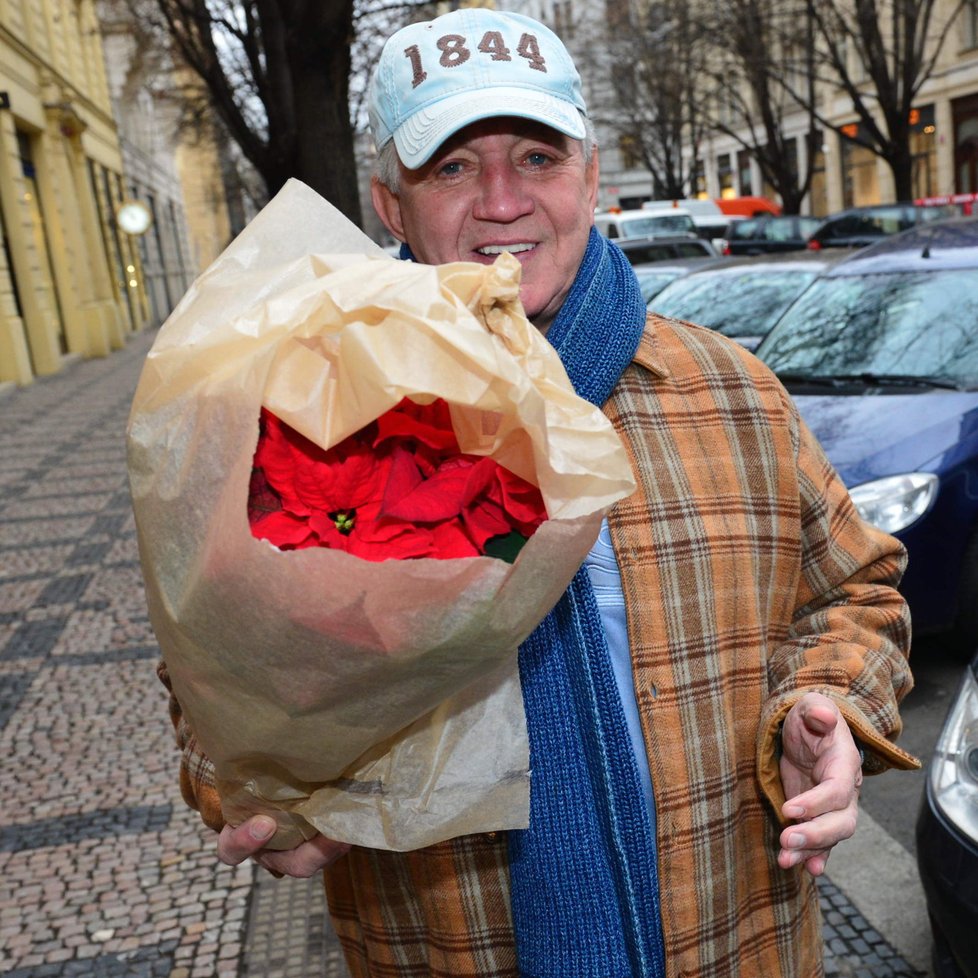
[929,668,978,841]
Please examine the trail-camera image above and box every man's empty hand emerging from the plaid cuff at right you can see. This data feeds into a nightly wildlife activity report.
[778,693,863,876]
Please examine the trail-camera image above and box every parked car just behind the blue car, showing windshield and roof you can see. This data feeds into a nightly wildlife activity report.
[651,251,838,350]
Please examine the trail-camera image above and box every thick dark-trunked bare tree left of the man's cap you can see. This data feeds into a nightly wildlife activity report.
[140,0,428,224]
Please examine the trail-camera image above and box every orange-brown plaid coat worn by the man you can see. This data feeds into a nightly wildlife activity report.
[163,317,917,978]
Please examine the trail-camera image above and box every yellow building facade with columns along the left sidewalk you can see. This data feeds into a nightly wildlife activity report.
[0,0,148,384]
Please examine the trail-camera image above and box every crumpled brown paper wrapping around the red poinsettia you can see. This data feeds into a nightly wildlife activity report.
[128,181,634,850]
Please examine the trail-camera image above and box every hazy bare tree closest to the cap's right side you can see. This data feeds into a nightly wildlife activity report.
[592,0,703,198]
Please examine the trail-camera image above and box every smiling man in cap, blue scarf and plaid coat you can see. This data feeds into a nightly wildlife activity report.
[164,9,916,978]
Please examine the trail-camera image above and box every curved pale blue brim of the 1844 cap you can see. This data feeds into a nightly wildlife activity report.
[394,88,585,170]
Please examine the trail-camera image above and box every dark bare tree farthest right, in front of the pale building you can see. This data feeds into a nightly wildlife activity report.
[792,0,966,200]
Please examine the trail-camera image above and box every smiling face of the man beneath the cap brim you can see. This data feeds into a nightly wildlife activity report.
[373,118,598,331]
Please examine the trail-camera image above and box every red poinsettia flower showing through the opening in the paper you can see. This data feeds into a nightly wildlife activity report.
[248,398,546,560]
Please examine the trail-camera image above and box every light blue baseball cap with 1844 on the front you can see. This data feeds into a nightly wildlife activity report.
[368,7,587,170]
